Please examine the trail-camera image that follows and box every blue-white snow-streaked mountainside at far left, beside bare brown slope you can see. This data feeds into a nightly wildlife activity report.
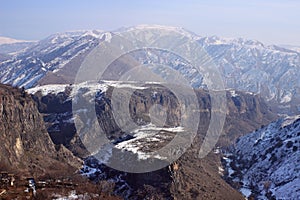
[0,31,103,88]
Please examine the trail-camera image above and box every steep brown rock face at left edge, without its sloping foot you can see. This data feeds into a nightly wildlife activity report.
[0,85,53,164]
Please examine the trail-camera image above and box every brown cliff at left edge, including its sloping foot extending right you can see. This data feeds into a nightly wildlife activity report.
[0,85,80,177]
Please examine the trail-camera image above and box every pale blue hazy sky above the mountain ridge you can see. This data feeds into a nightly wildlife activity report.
[0,0,300,46]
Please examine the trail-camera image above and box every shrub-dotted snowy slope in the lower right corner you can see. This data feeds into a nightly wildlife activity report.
[225,116,300,199]
